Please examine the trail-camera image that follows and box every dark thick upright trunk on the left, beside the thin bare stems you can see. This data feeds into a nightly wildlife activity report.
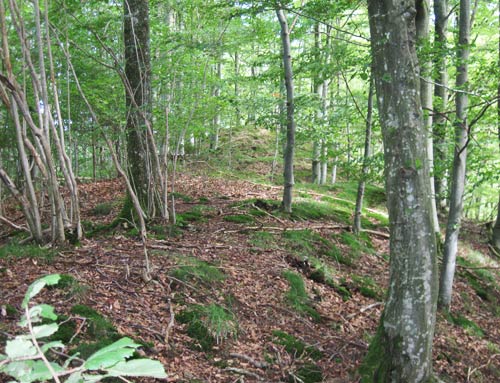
[123,0,154,216]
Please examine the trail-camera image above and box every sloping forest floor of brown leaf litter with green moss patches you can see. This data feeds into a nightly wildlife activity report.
[0,170,500,383]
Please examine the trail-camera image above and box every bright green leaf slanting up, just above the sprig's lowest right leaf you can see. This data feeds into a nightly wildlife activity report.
[84,338,140,370]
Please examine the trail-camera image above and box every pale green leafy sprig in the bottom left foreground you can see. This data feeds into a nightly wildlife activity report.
[0,274,166,383]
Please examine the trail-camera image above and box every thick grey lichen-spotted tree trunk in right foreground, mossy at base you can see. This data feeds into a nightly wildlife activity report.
[361,0,437,383]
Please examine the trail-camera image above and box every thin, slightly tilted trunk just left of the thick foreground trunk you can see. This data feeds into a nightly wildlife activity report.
[352,77,374,234]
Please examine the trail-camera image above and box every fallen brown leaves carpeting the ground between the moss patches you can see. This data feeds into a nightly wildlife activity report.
[0,176,500,382]
